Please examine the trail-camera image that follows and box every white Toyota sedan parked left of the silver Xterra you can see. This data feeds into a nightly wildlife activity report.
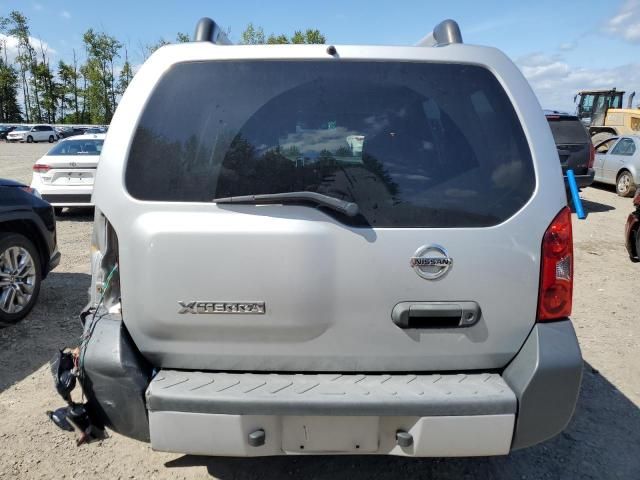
[31,134,105,212]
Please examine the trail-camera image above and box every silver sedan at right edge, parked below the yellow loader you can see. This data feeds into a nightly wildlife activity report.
[595,135,640,197]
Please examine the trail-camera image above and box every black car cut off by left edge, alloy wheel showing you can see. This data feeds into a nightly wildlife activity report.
[0,179,60,325]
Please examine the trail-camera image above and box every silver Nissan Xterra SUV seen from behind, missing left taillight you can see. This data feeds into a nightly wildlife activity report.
[81,19,582,457]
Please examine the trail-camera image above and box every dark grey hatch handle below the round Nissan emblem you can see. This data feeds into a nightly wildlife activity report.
[391,301,481,329]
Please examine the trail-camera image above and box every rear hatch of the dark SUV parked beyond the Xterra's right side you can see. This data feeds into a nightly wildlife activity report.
[547,115,591,175]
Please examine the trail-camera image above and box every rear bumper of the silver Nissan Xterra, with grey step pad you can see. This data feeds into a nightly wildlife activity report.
[79,318,582,457]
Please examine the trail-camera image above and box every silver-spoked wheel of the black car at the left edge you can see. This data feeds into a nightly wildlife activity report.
[0,233,42,324]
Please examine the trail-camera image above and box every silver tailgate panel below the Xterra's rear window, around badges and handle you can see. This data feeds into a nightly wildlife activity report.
[120,206,544,371]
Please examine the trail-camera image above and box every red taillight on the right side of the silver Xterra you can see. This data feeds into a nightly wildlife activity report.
[538,207,573,322]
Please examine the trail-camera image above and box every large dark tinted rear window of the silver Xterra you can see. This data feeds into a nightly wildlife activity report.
[125,61,535,227]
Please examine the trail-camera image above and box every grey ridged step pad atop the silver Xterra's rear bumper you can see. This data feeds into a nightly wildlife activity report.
[146,370,517,416]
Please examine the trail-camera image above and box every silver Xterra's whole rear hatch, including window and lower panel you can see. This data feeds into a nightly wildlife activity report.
[112,60,561,372]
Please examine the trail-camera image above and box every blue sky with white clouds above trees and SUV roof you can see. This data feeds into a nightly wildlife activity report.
[0,0,640,112]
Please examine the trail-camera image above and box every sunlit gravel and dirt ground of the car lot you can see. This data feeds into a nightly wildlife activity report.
[0,143,640,479]
